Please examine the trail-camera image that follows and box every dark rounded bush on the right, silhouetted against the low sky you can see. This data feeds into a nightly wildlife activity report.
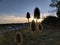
[41,16,58,28]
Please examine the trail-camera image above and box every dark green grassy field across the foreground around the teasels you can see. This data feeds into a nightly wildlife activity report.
[0,29,60,45]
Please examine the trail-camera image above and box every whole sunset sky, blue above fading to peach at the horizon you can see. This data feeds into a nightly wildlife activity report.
[0,0,55,24]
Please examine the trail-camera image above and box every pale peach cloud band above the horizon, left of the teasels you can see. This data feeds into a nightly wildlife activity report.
[0,16,27,24]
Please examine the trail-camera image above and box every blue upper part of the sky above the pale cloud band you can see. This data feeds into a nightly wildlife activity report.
[0,0,54,23]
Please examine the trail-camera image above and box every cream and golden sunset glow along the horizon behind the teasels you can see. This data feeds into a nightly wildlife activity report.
[0,16,43,24]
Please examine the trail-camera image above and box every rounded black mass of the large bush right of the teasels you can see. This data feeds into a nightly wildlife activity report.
[42,16,58,25]
